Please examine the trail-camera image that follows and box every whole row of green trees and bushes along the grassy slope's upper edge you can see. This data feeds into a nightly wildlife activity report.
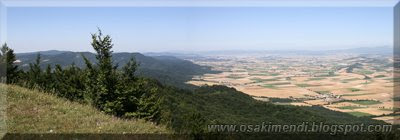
[14,30,162,121]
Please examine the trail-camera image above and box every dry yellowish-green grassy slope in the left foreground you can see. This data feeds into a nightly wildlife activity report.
[0,84,170,133]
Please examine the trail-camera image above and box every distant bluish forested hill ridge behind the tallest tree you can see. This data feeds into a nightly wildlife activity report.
[16,50,216,88]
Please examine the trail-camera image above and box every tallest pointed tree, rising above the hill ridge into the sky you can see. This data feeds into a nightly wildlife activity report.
[84,29,118,114]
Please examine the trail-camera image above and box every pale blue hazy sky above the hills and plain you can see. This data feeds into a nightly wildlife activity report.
[7,7,393,53]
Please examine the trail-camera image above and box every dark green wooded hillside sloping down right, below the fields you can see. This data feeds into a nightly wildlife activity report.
[163,86,385,132]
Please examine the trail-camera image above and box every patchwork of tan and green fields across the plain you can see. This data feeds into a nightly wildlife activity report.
[188,54,396,122]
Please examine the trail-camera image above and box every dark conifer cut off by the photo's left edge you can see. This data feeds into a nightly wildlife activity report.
[1,43,18,84]
